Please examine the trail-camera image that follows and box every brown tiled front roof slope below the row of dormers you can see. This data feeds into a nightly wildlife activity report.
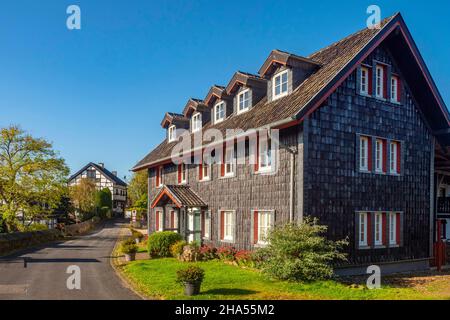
[133,15,397,171]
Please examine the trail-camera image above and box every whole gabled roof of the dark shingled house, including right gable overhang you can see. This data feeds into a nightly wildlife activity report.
[133,14,450,171]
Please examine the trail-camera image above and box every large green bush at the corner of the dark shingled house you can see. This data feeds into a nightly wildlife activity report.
[255,218,348,281]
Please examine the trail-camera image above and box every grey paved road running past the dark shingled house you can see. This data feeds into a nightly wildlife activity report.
[0,221,139,300]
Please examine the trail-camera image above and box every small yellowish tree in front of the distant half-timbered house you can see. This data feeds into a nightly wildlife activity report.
[70,179,97,220]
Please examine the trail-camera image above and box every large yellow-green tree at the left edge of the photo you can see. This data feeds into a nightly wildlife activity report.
[0,126,69,232]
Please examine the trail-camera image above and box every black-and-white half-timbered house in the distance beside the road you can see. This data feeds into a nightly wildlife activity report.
[69,162,127,214]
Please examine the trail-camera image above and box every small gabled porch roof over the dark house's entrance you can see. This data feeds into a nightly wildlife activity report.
[151,185,207,208]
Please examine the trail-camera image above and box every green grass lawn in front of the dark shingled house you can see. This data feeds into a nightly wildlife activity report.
[121,258,450,300]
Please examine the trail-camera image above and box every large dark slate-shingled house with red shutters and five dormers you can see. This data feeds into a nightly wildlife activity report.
[133,14,450,271]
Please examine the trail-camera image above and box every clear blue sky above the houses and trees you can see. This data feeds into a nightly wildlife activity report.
[0,0,450,180]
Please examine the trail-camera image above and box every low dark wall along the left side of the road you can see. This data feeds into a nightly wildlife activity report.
[0,230,63,256]
